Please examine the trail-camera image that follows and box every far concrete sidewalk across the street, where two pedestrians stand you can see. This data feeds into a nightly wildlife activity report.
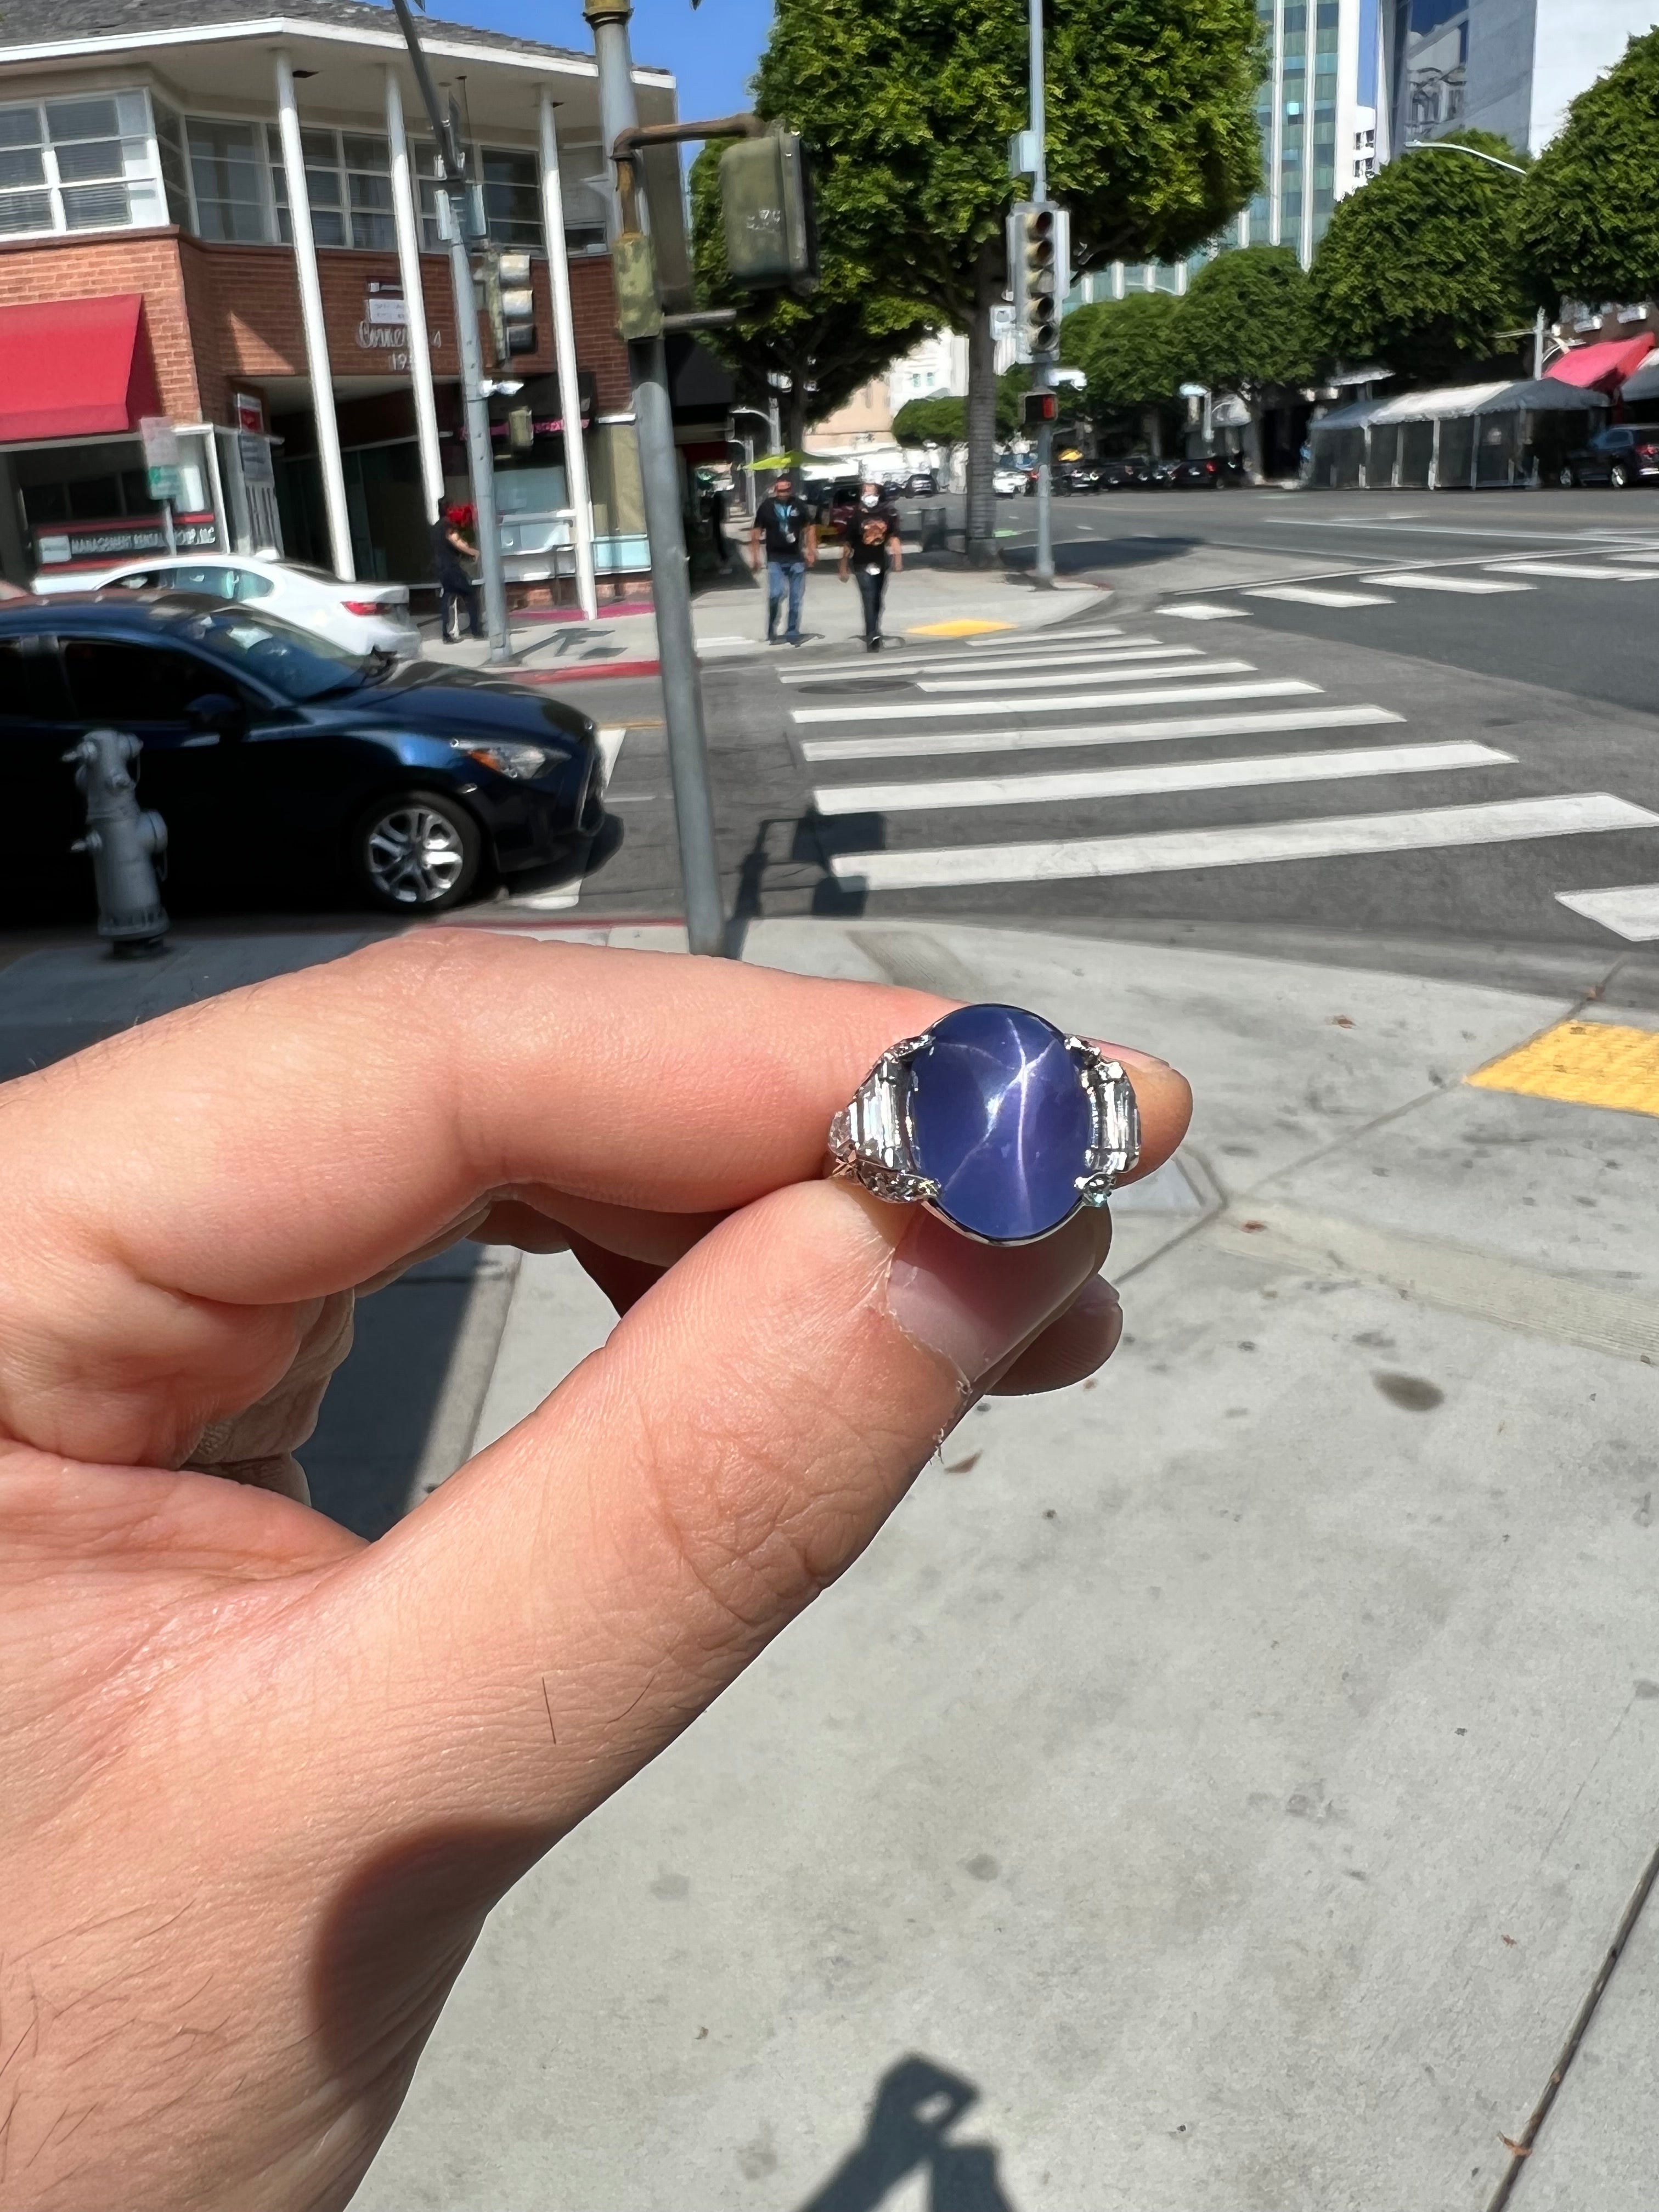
[422,546,1110,679]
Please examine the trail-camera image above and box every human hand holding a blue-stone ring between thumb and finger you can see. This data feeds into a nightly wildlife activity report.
[0,931,1188,2212]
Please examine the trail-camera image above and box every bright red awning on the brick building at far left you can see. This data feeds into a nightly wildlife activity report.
[0,292,161,444]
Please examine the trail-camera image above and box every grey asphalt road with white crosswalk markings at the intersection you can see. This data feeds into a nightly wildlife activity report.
[555,491,1659,995]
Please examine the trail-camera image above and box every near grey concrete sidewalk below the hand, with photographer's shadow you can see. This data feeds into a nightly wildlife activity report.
[0,920,1659,2212]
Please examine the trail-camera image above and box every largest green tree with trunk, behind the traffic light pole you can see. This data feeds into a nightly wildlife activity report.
[757,0,1263,560]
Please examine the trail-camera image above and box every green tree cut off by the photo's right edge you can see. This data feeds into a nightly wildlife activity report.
[1513,31,1659,303]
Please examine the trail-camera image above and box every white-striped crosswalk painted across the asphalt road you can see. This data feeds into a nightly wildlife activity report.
[781,619,1659,902]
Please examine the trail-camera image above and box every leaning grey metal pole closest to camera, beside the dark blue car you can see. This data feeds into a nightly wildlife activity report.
[584,0,725,953]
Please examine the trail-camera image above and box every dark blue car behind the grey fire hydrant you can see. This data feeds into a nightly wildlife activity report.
[0,591,606,913]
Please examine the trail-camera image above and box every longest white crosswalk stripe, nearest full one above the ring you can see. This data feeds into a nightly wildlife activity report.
[830,792,1659,891]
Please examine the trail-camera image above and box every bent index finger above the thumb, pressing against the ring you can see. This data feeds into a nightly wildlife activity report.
[0,931,1188,1460]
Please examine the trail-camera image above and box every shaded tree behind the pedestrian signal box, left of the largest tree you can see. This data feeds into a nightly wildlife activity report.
[690,144,938,454]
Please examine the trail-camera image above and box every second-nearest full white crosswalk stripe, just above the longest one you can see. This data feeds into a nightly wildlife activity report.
[812,739,1515,814]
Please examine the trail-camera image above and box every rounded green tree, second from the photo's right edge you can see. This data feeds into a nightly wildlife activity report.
[1312,131,1528,383]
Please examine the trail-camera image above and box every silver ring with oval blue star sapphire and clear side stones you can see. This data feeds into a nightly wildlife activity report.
[830,1007,1142,1243]
